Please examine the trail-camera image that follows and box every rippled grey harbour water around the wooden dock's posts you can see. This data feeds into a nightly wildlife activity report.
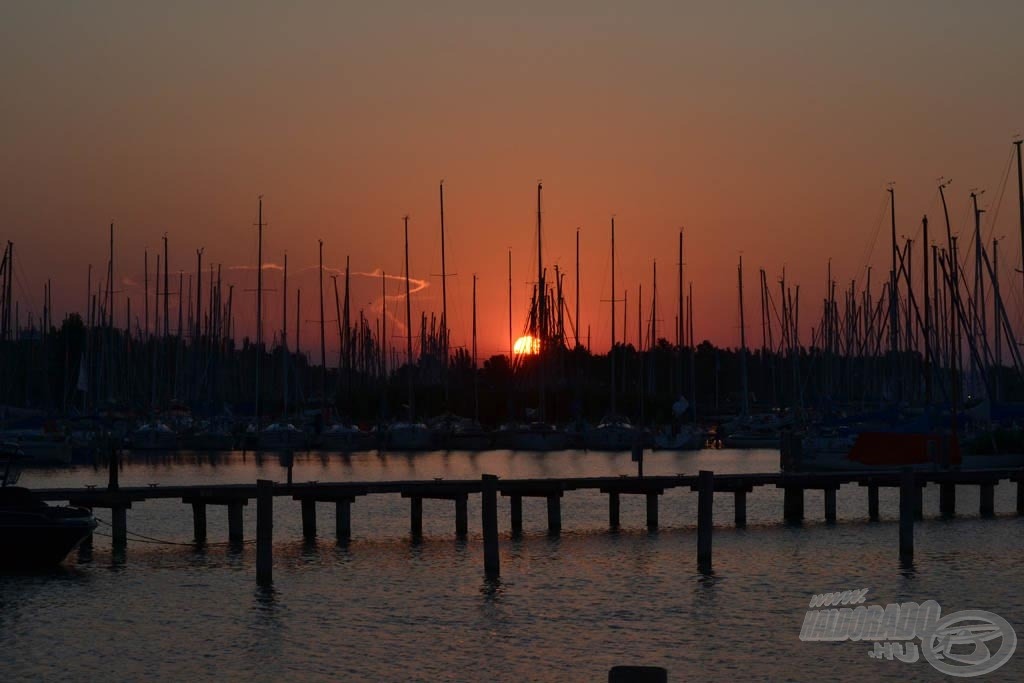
[0,451,1024,681]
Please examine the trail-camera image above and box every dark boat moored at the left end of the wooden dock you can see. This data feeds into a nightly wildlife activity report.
[0,486,96,568]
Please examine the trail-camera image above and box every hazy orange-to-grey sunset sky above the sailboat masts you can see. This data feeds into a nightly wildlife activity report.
[0,0,1024,361]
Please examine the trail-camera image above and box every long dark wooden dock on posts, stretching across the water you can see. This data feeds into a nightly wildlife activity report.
[36,469,1024,584]
